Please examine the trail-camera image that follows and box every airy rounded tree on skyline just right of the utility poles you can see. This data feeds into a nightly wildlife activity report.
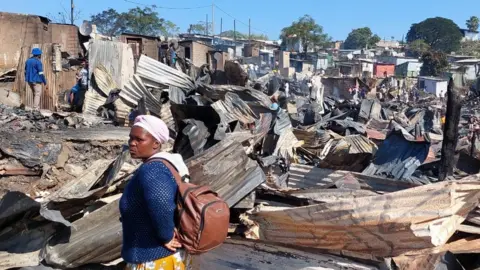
[280,15,331,54]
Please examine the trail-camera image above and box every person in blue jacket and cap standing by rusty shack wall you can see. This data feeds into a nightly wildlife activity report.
[25,48,48,110]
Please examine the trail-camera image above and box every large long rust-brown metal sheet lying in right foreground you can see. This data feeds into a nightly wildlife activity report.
[252,180,480,257]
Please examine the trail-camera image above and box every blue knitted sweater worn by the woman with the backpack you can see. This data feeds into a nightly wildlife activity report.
[120,161,178,263]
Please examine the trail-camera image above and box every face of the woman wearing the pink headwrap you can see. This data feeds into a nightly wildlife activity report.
[128,127,161,159]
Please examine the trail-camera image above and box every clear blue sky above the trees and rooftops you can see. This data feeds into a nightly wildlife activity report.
[0,0,480,40]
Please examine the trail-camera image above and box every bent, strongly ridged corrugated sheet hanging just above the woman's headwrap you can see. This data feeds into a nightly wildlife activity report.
[120,75,162,116]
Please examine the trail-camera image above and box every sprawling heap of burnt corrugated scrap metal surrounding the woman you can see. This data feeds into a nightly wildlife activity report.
[0,55,480,269]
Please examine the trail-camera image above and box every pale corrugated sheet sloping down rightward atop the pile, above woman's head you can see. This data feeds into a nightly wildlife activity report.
[137,55,196,92]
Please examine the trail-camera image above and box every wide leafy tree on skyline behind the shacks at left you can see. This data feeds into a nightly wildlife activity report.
[91,6,179,36]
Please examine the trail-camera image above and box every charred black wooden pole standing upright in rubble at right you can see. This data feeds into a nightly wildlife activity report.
[438,79,462,181]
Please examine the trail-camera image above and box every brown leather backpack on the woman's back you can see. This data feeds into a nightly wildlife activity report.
[152,159,230,255]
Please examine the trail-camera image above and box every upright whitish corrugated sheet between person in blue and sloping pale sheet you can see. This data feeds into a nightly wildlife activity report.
[88,40,135,89]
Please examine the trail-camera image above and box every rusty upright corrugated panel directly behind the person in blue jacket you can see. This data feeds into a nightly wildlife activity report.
[15,43,58,111]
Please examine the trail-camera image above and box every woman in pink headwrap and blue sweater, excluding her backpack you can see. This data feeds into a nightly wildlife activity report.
[120,115,190,270]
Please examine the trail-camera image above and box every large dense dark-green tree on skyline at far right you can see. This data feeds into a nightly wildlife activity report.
[407,17,462,53]
